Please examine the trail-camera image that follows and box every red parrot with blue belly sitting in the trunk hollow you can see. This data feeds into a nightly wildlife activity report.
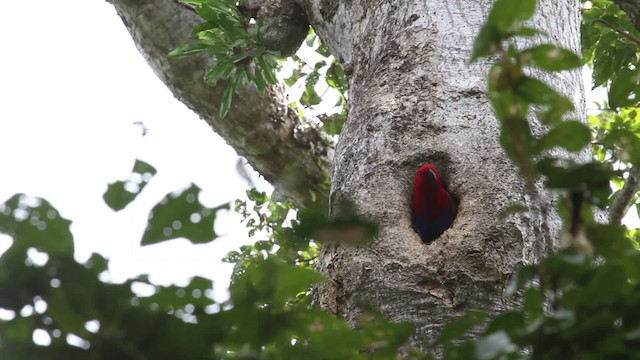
[411,164,458,244]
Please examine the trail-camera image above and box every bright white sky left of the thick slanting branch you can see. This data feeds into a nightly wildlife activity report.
[0,0,270,300]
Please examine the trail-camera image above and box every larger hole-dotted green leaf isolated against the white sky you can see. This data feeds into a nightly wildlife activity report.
[142,184,229,245]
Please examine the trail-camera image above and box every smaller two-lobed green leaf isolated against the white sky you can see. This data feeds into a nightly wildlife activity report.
[102,159,156,211]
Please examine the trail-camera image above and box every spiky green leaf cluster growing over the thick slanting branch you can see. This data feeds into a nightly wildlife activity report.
[169,0,278,117]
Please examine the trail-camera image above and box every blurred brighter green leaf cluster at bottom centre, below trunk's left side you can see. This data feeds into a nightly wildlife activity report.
[217,257,413,360]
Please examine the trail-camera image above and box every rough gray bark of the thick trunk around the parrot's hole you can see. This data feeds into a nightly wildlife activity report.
[305,0,584,346]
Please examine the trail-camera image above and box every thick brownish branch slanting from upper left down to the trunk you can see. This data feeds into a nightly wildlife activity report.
[107,0,332,208]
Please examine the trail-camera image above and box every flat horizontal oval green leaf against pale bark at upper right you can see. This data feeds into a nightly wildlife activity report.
[520,44,582,71]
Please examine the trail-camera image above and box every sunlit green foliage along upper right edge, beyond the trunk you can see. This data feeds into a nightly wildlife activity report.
[582,0,640,218]
